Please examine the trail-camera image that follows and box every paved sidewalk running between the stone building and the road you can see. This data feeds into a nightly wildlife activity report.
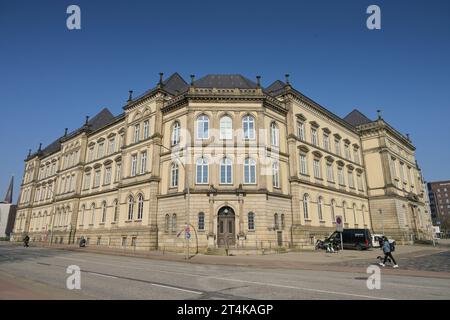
[4,242,450,278]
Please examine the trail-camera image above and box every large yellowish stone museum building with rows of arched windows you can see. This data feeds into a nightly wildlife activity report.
[10,74,429,252]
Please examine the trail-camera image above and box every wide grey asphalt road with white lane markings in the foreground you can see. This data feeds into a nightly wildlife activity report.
[0,245,450,300]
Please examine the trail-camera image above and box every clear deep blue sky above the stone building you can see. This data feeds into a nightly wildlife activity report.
[0,0,450,202]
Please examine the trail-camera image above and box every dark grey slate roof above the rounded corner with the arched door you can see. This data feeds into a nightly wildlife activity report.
[194,74,257,89]
